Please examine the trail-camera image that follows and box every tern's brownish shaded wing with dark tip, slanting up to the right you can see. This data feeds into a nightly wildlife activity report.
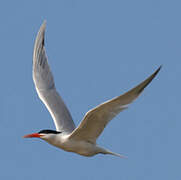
[69,66,161,143]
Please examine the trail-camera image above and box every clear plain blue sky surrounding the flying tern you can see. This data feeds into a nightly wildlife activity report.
[0,0,181,180]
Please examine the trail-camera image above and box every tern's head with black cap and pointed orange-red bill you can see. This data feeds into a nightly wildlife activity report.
[23,129,61,140]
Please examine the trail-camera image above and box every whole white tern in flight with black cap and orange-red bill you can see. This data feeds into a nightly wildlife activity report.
[24,21,161,158]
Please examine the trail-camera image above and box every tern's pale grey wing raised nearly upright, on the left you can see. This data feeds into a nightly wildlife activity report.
[33,22,75,133]
